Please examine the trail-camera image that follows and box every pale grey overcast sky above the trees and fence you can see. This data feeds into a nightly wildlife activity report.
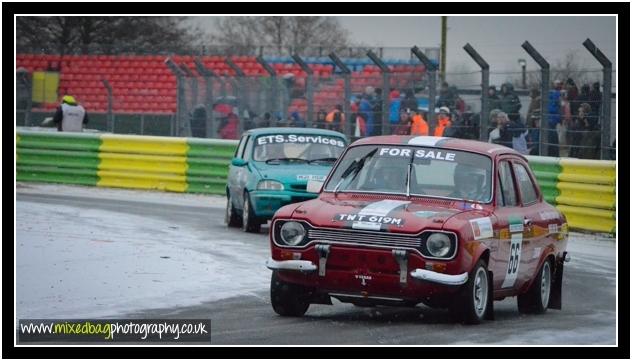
[194,16,616,82]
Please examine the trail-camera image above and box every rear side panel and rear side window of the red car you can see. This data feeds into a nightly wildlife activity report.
[512,159,549,284]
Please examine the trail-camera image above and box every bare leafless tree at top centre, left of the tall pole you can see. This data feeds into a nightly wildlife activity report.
[211,16,349,55]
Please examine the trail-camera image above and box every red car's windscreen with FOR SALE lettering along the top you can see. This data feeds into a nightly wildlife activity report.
[324,145,492,203]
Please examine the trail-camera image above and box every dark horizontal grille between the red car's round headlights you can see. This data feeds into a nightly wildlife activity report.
[307,228,421,248]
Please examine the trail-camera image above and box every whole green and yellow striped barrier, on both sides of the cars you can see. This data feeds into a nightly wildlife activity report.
[16,130,616,233]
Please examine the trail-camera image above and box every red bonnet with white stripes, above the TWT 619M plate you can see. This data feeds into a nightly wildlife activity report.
[292,193,489,233]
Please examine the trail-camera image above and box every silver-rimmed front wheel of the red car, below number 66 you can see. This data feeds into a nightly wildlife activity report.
[450,260,493,325]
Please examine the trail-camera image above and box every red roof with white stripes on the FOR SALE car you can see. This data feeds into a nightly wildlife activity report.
[351,135,526,160]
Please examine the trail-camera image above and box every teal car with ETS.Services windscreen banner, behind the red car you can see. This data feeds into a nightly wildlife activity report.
[225,128,348,233]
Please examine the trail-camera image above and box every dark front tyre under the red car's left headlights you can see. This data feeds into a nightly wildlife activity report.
[270,272,310,317]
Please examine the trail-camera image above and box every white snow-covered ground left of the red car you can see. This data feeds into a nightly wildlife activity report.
[16,198,270,318]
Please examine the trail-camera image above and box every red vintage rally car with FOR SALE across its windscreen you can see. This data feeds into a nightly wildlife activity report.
[267,136,568,323]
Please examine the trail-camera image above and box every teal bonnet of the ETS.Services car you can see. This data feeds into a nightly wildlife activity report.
[254,162,333,184]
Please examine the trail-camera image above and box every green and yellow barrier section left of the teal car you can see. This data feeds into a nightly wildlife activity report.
[16,130,237,194]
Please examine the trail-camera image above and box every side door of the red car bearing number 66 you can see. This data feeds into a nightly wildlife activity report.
[493,157,524,296]
